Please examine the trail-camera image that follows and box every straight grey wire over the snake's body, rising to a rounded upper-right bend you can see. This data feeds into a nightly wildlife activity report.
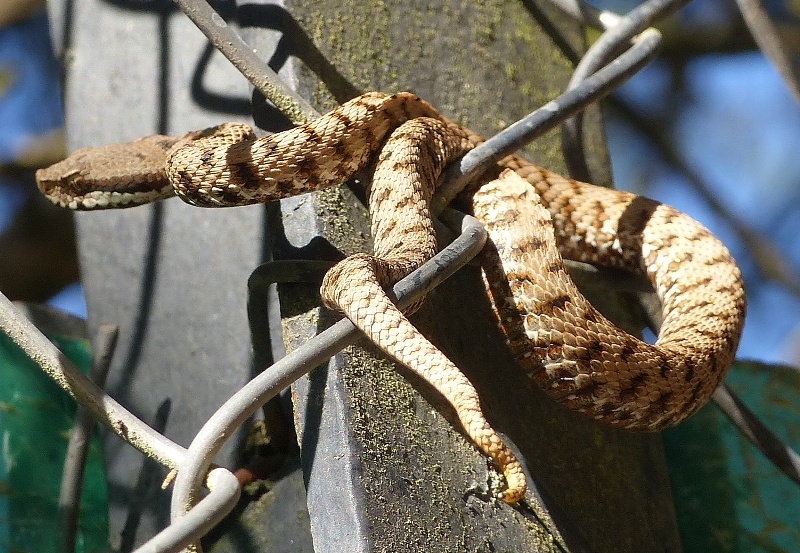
[431,29,661,213]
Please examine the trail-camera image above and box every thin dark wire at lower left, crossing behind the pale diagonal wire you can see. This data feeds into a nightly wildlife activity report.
[58,324,119,553]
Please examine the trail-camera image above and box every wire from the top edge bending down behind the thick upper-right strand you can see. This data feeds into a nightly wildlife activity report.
[561,0,689,182]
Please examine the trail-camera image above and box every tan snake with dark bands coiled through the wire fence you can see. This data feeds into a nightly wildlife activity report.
[36,92,746,503]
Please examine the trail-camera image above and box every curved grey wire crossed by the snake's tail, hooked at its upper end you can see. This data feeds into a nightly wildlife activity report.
[171,210,486,521]
